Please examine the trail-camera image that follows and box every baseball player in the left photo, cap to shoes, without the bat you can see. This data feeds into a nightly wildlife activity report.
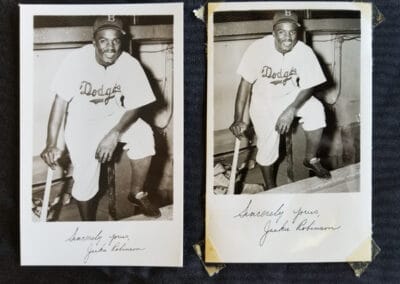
[41,16,161,221]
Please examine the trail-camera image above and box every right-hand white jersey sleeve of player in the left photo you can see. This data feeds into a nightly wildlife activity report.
[122,56,155,109]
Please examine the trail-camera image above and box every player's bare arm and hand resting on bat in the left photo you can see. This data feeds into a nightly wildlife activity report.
[40,95,68,170]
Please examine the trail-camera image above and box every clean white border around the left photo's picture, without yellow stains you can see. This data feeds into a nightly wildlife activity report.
[20,3,184,267]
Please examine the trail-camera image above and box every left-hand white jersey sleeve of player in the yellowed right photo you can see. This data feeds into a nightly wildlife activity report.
[236,42,259,84]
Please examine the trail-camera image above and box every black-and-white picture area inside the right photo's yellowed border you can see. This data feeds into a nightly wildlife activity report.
[213,9,361,194]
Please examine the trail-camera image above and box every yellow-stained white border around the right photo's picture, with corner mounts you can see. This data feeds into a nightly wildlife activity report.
[205,2,372,263]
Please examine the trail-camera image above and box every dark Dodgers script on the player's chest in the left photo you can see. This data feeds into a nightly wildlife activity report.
[79,81,121,105]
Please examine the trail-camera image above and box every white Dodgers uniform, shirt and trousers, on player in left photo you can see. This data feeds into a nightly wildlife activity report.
[51,44,155,201]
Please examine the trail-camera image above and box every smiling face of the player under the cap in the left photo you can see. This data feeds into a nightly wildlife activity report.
[93,29,122,66]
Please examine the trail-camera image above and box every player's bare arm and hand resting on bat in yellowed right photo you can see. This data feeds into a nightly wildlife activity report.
[229,78,252,139]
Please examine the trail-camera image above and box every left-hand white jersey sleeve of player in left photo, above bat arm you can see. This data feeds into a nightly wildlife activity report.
[50,49,76,102]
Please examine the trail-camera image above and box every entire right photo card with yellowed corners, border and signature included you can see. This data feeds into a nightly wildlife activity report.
[206,2,372,262]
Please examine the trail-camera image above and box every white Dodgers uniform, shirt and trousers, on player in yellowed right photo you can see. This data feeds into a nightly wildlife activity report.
[237,35,326,166]
